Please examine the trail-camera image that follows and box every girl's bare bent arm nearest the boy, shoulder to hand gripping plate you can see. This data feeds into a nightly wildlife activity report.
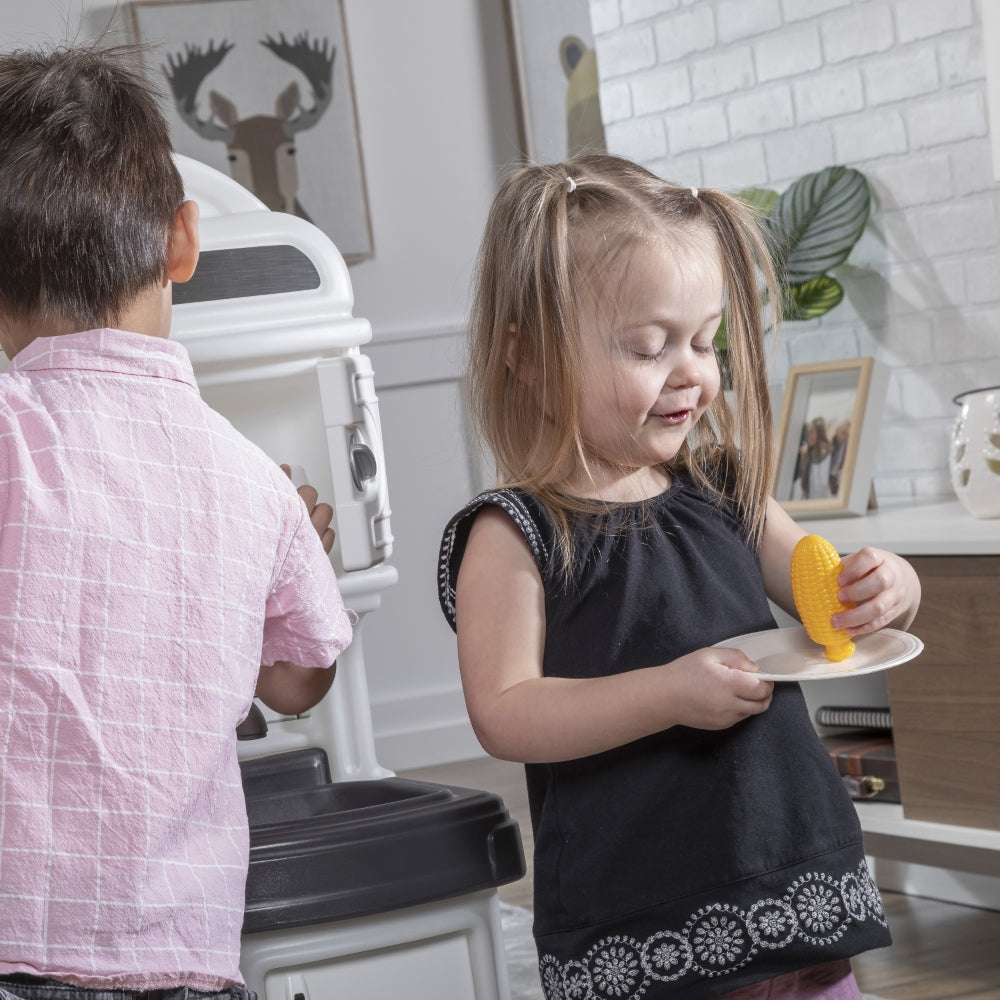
[456,507,773,762]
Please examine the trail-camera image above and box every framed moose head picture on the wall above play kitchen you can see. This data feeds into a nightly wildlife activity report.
[130,0,372,263]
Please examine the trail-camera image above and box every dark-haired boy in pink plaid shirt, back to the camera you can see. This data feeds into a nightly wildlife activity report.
[0,48,351,1000]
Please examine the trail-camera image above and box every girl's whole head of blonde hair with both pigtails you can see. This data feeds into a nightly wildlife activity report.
[468,154,780,570]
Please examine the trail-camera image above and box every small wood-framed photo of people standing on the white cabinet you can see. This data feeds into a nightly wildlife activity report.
[772,358,888,518]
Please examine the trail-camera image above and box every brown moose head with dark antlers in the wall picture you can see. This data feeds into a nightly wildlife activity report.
[163,32,337,221]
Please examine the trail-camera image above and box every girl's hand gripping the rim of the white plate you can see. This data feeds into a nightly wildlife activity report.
[659,647,774,729]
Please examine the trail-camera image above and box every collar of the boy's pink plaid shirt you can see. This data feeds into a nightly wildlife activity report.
[7,329,197,390]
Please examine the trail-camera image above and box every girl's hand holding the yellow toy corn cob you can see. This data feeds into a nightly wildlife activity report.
[830,547,920,635]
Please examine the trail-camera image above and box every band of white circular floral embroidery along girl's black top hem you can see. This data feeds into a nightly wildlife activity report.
[539,862,886,1000]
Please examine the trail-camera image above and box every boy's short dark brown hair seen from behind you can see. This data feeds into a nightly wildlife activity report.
[0,47,184,330]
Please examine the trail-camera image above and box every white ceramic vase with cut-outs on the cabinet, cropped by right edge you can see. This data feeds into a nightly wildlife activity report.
[949,385,1000,517]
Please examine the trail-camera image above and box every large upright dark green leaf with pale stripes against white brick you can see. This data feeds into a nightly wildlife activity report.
[770,166,871,285]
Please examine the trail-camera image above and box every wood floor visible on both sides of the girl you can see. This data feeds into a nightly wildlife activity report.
[402,757,1000,1000]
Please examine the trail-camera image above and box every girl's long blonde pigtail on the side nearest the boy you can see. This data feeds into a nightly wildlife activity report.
[467,165,585,567]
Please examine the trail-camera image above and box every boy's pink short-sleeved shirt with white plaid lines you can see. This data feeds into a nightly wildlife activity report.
[0,330,351,990]
